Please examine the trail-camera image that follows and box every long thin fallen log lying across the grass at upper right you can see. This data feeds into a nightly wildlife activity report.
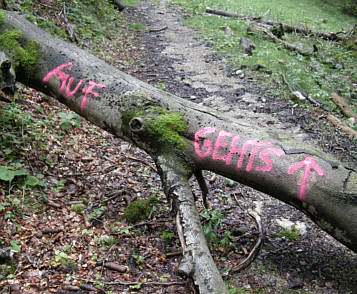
[206,7,348,41]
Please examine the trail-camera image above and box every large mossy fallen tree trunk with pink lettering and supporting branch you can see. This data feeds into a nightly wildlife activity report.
[0,12,357,293]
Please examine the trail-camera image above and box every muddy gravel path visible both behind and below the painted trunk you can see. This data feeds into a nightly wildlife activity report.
[121,0,357,294]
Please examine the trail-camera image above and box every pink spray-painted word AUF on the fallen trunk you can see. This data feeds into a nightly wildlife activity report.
[42,62,106,111]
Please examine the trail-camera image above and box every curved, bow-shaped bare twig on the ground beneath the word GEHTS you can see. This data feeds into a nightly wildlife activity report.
[232,194,264,273]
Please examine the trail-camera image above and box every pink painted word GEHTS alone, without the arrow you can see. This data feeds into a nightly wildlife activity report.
[194,127,285,172]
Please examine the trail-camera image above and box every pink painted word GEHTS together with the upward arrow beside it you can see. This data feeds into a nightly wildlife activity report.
[194,127,324,200]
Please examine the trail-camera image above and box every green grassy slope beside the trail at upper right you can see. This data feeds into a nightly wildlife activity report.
[172,0,357,121]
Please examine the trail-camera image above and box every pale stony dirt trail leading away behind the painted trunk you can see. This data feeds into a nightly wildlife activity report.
[136,0,304,137]
